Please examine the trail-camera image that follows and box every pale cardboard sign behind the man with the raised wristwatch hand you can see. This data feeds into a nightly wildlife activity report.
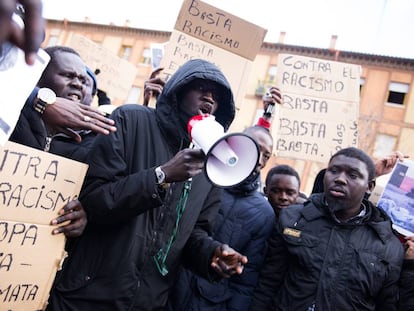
[69,34,137,100]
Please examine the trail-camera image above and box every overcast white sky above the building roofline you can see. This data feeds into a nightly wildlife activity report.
[43,0,414,59]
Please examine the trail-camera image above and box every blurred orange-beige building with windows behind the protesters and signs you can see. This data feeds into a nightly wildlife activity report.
[43,19,414,194]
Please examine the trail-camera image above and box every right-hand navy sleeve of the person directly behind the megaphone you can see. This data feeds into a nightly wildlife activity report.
[227,207,275,311]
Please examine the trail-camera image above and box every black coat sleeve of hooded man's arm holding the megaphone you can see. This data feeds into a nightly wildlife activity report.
[80,110,162,224]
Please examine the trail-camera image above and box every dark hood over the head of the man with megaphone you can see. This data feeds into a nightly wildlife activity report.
[156,59,235,152]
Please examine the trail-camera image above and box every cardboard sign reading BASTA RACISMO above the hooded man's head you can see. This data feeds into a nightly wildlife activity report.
[160,0,267,108]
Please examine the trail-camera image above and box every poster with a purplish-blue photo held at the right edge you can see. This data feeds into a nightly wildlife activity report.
[377,160,414,236]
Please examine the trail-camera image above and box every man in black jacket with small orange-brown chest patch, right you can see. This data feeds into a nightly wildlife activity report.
[251,147,404,311]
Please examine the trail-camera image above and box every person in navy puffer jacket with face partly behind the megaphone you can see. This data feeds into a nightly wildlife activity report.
[168,126,275,311]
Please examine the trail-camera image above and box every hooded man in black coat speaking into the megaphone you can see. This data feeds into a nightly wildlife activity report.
[48,59,247,311]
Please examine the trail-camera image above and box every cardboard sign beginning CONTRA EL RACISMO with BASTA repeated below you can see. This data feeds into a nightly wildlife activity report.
[272,54,361,163]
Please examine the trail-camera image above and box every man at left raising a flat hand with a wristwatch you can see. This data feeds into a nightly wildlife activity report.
[10,46,115,162]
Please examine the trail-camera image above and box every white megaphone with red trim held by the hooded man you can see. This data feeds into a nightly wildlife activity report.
[188,115,260,188]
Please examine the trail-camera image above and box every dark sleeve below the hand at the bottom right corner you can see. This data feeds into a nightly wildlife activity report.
[398,259,414,311]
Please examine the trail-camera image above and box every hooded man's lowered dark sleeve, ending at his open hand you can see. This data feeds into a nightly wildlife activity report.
[183,187,222,281]
